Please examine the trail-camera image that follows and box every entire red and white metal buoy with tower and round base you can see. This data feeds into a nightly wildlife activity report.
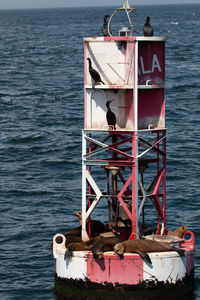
[53,1,194,295]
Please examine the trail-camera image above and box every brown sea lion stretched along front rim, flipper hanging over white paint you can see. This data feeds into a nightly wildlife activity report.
[114,239,185,263]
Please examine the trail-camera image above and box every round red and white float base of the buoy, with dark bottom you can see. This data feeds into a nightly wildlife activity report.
[53,233,194,300]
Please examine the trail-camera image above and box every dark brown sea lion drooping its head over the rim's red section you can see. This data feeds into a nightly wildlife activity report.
[92,236,123,259]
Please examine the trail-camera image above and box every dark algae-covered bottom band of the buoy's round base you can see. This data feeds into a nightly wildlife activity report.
[55,274,194,300]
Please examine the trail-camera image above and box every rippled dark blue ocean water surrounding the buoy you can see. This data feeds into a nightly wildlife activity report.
[0,5,200,300]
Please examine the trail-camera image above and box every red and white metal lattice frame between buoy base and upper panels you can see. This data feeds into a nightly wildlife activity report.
[82,37,166,240]
